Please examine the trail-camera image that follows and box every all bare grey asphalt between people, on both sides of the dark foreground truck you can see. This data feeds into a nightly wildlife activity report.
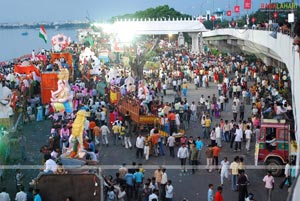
[3,81,287,201]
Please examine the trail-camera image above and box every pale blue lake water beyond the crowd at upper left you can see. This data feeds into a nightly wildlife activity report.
[0,29,77,62]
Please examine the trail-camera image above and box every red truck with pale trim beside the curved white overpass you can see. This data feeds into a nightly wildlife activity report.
[255,119,297,176]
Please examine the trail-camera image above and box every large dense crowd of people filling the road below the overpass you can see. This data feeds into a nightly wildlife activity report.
[0,33,293,201]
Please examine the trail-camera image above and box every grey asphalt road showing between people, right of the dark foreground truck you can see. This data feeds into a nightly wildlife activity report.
[100,81,287,201]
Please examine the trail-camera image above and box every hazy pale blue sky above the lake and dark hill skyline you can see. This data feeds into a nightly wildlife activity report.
[0,0,290,23]
